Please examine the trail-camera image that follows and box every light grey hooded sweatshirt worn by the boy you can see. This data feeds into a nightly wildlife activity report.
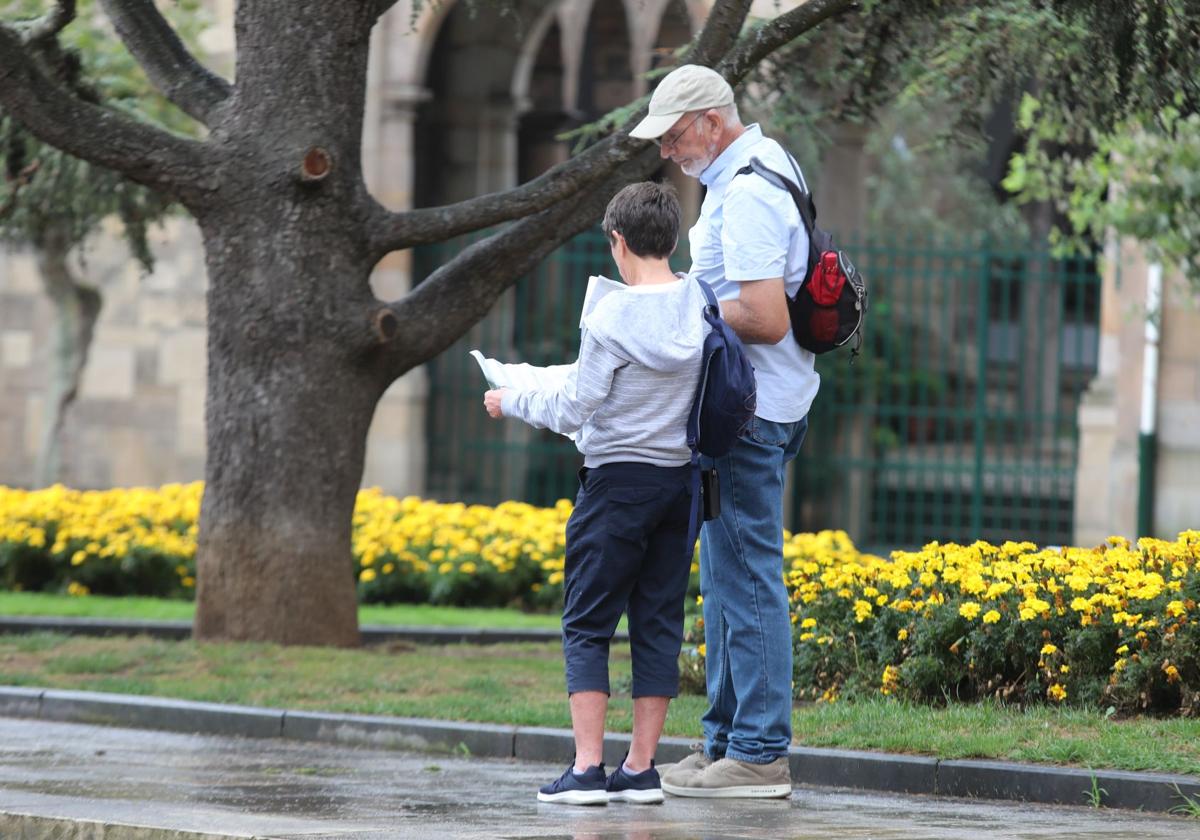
[500,278,709,467]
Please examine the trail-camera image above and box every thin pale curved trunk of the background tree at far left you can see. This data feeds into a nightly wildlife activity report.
[34,223,102,487]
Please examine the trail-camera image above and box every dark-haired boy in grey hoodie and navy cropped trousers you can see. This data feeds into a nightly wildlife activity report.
[484,182,708,805]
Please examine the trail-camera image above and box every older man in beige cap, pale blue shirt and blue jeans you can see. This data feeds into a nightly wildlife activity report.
[630,65,820,797]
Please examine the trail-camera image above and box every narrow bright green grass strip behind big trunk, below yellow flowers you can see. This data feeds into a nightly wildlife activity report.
[0,592,559,630]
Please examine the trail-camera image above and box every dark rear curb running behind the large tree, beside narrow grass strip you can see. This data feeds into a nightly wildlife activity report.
[0,616,614,644]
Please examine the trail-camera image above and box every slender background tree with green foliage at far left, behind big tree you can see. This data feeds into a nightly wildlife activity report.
[0,0,205,487]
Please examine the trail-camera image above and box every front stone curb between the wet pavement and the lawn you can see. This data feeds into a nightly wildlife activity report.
[0,686,1200,812]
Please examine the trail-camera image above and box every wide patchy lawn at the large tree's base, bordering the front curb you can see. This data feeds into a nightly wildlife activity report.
[0,634,1200,776]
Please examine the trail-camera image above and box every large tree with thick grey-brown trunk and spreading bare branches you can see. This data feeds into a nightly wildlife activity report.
[0,0,852,644]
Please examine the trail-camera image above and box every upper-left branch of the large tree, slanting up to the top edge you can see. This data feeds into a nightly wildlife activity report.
[101,0,232,125]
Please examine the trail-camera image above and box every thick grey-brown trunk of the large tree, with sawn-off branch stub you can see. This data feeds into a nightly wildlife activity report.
[193,4,390,646]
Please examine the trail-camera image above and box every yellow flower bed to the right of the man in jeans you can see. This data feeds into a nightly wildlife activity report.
[785,530,1200,714]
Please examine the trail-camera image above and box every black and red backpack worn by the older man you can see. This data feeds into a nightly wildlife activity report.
[737,155,866,355]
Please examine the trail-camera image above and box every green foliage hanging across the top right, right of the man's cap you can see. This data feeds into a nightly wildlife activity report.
[758,0,1200,282]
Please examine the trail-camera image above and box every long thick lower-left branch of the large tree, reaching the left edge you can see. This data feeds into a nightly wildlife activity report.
[0,25,214,203]
